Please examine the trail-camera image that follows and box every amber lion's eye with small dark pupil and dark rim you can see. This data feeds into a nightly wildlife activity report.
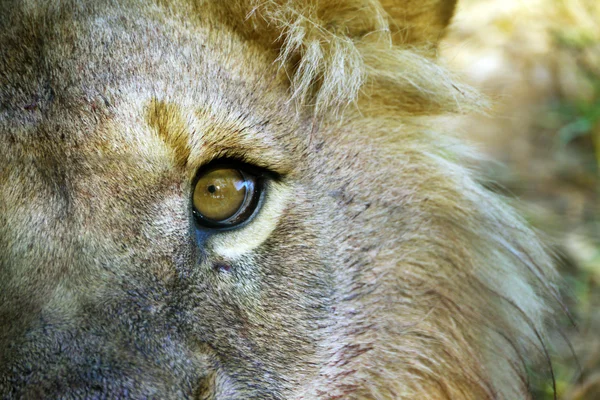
[192,165,261,228]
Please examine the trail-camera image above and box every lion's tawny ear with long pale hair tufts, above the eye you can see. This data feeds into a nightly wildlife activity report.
[219,0,485,115]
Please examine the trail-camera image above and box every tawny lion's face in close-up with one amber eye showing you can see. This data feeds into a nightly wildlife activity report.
[0,0,560,400]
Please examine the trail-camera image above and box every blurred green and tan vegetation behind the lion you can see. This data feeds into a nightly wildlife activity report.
[441,0,600,400]
